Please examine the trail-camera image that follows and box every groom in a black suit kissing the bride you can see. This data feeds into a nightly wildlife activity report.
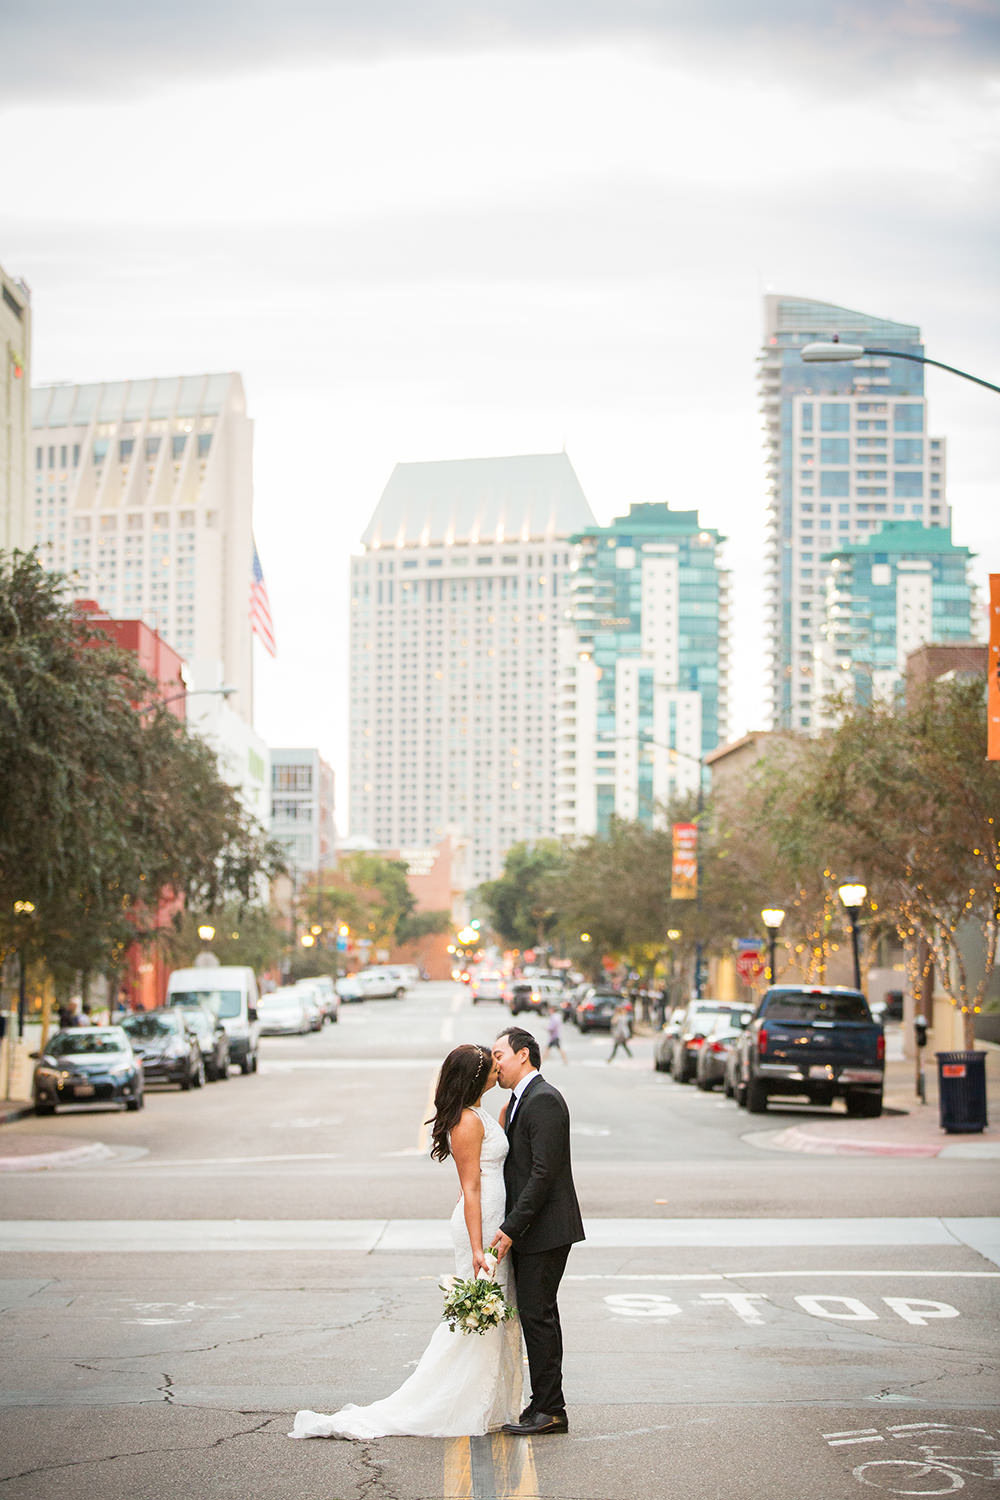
[493,1026,583,1437]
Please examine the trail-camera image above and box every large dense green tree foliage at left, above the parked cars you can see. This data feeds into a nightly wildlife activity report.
[0,552,279,977]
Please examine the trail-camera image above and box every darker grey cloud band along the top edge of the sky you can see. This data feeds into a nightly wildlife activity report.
[7,0,1000,99]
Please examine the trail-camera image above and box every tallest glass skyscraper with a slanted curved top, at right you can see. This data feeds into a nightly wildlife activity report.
[760,296,951,731]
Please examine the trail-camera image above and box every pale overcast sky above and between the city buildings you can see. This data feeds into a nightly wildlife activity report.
[0,0,1000,830]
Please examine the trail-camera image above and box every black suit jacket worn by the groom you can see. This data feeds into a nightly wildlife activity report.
[501,1076,585,1254]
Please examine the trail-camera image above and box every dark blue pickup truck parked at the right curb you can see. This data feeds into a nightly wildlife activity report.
[736,984,886,1118]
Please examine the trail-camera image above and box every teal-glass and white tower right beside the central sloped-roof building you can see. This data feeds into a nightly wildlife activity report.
[559,504,730,837]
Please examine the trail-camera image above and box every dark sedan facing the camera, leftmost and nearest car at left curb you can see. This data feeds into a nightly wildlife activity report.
[31,1026,144,1115]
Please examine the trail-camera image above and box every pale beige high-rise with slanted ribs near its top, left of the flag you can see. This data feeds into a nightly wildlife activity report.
[33,374,253,720]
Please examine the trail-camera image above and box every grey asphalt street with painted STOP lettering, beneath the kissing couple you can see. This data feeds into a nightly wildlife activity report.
[0,986,1000,1500]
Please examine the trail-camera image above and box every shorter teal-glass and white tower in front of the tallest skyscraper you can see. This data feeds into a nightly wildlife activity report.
[816,521,975,726]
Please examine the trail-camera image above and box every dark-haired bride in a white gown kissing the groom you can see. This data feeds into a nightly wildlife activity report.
[288,1044,522,1439]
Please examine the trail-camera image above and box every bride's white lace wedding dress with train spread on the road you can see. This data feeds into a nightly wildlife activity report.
[288,1110,522,1439]
